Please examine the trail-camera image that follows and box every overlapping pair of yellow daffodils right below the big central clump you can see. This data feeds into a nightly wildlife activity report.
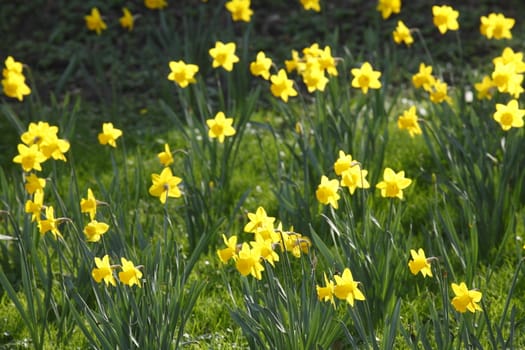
[316,268,365,307]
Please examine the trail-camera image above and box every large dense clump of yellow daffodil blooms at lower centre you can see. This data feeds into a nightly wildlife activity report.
[217,207,312,280]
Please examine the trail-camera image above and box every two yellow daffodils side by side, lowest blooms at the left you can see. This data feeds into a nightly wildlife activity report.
[91,254,142,288]
